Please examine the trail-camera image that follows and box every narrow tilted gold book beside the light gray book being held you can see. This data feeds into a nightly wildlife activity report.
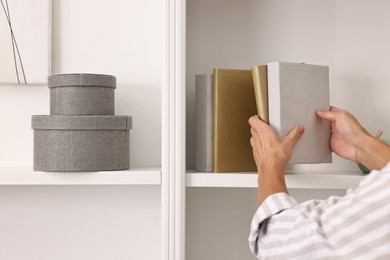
[252,65,268,124]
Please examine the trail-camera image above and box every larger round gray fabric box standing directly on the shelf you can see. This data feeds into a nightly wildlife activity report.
[32,116,132,172]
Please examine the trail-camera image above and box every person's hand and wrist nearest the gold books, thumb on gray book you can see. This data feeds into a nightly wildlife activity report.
[249,116,304,205]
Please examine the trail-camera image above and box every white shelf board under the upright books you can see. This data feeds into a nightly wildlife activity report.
[186,172,365,189]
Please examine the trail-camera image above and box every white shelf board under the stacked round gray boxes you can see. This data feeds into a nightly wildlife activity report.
[0,167,161,185]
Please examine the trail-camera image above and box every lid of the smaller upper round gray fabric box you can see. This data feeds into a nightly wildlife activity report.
[48,73,116,88]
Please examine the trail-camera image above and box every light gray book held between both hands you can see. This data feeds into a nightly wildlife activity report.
[267,62,332,163]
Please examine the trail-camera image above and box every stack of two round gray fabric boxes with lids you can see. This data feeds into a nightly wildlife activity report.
[32,74,132,172]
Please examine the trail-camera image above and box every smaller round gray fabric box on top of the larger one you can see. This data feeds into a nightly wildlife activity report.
[48,74,116,115]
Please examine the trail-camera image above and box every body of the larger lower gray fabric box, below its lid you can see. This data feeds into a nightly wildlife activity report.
[34,130,130,172]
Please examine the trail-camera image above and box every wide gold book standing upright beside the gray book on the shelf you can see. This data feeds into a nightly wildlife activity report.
[213,68,256,172]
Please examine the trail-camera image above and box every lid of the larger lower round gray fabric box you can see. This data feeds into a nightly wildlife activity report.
[31,115,132,130]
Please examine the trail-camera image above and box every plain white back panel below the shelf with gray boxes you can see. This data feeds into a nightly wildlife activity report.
[0,186,160,260]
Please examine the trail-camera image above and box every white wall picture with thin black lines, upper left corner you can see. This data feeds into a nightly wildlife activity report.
[0,0,51,86]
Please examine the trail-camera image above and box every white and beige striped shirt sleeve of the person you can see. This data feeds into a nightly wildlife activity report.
[249,163,390,260]
